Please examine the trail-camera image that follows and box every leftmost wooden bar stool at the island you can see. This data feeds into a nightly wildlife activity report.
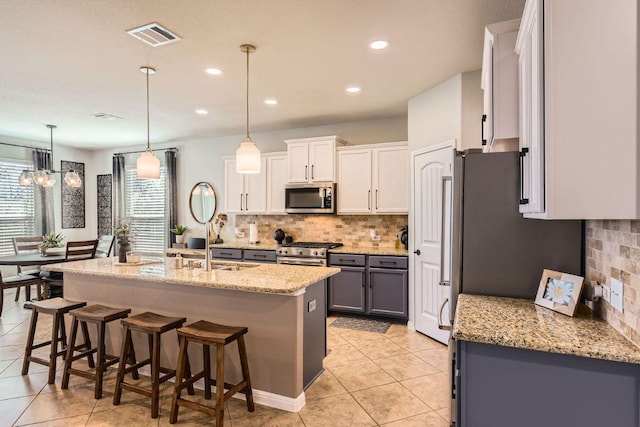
[22,298,94,384]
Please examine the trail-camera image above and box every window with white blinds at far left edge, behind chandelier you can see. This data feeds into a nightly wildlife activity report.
[0,159,36,255]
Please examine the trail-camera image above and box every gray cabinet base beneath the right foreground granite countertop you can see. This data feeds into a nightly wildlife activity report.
[455,341,640,427]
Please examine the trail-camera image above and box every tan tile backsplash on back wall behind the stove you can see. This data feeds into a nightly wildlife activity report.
[235,214,408,247]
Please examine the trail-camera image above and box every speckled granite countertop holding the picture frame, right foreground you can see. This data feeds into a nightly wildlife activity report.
[453,294,640,363]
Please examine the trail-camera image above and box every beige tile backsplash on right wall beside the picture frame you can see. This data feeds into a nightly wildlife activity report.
[585,220,640,345]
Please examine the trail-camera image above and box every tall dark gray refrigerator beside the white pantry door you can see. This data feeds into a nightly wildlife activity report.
[440,150,584,425]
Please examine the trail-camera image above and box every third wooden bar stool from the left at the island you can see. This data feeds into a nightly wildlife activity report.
[113,312,194,418]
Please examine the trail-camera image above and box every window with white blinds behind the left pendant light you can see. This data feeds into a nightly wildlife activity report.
[125,166,168,254]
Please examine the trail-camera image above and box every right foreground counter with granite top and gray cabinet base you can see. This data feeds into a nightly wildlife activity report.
[453,294,640,427]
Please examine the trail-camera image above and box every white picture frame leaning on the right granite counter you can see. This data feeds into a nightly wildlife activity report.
[536,269,584,317]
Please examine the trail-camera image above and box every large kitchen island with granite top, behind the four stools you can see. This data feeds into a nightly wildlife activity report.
[46,258,340,412]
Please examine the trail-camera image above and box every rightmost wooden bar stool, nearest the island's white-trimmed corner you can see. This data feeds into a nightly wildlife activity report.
[169,320,255,427]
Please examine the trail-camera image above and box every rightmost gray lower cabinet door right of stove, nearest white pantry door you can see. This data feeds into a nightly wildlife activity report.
[368,267,409,317]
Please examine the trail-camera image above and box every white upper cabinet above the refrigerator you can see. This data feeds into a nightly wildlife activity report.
[481,19,520,152]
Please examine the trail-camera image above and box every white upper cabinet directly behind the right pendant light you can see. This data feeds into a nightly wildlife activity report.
[224,157,267,214]
